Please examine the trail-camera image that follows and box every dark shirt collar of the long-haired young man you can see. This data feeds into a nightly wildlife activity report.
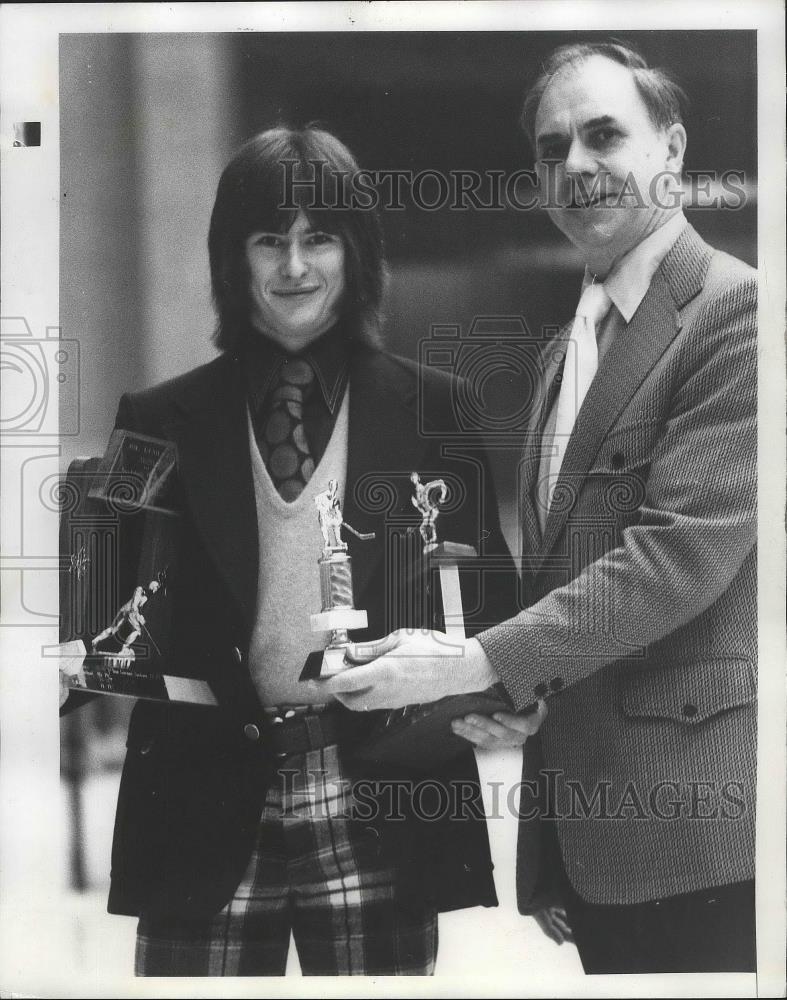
[238,327,351,414]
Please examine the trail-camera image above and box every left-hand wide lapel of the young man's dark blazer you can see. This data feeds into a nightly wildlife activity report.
[167,356,259,628]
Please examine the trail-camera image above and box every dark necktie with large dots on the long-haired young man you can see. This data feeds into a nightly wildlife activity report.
[256,358,314,503]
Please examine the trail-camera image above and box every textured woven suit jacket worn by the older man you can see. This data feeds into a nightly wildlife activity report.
[480,226,757,907]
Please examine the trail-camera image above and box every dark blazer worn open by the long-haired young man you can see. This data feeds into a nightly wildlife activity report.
[95,349,514,916]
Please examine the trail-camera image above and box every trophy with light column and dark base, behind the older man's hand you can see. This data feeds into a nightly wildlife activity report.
[359,472,511,768]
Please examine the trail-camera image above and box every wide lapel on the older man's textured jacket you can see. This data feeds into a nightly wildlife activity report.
[541,225,712,558]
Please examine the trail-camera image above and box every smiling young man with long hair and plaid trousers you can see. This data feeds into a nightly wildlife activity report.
[63,127,521,975]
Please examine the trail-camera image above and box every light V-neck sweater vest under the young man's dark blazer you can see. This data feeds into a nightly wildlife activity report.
[243,388,350,705]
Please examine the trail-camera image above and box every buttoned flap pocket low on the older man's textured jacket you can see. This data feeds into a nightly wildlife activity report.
[621,657,757,726]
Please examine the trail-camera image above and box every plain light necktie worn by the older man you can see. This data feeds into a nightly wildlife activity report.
[548,282,612,506]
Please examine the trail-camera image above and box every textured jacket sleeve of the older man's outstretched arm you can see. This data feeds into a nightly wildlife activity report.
[477,276,757,707]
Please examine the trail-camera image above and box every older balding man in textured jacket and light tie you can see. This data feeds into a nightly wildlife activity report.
[328,43,757,973]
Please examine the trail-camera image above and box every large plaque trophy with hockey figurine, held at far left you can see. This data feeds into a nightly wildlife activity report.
[55,430,217,705]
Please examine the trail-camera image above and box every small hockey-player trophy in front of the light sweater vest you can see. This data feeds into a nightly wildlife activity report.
[308,479,374,680]
